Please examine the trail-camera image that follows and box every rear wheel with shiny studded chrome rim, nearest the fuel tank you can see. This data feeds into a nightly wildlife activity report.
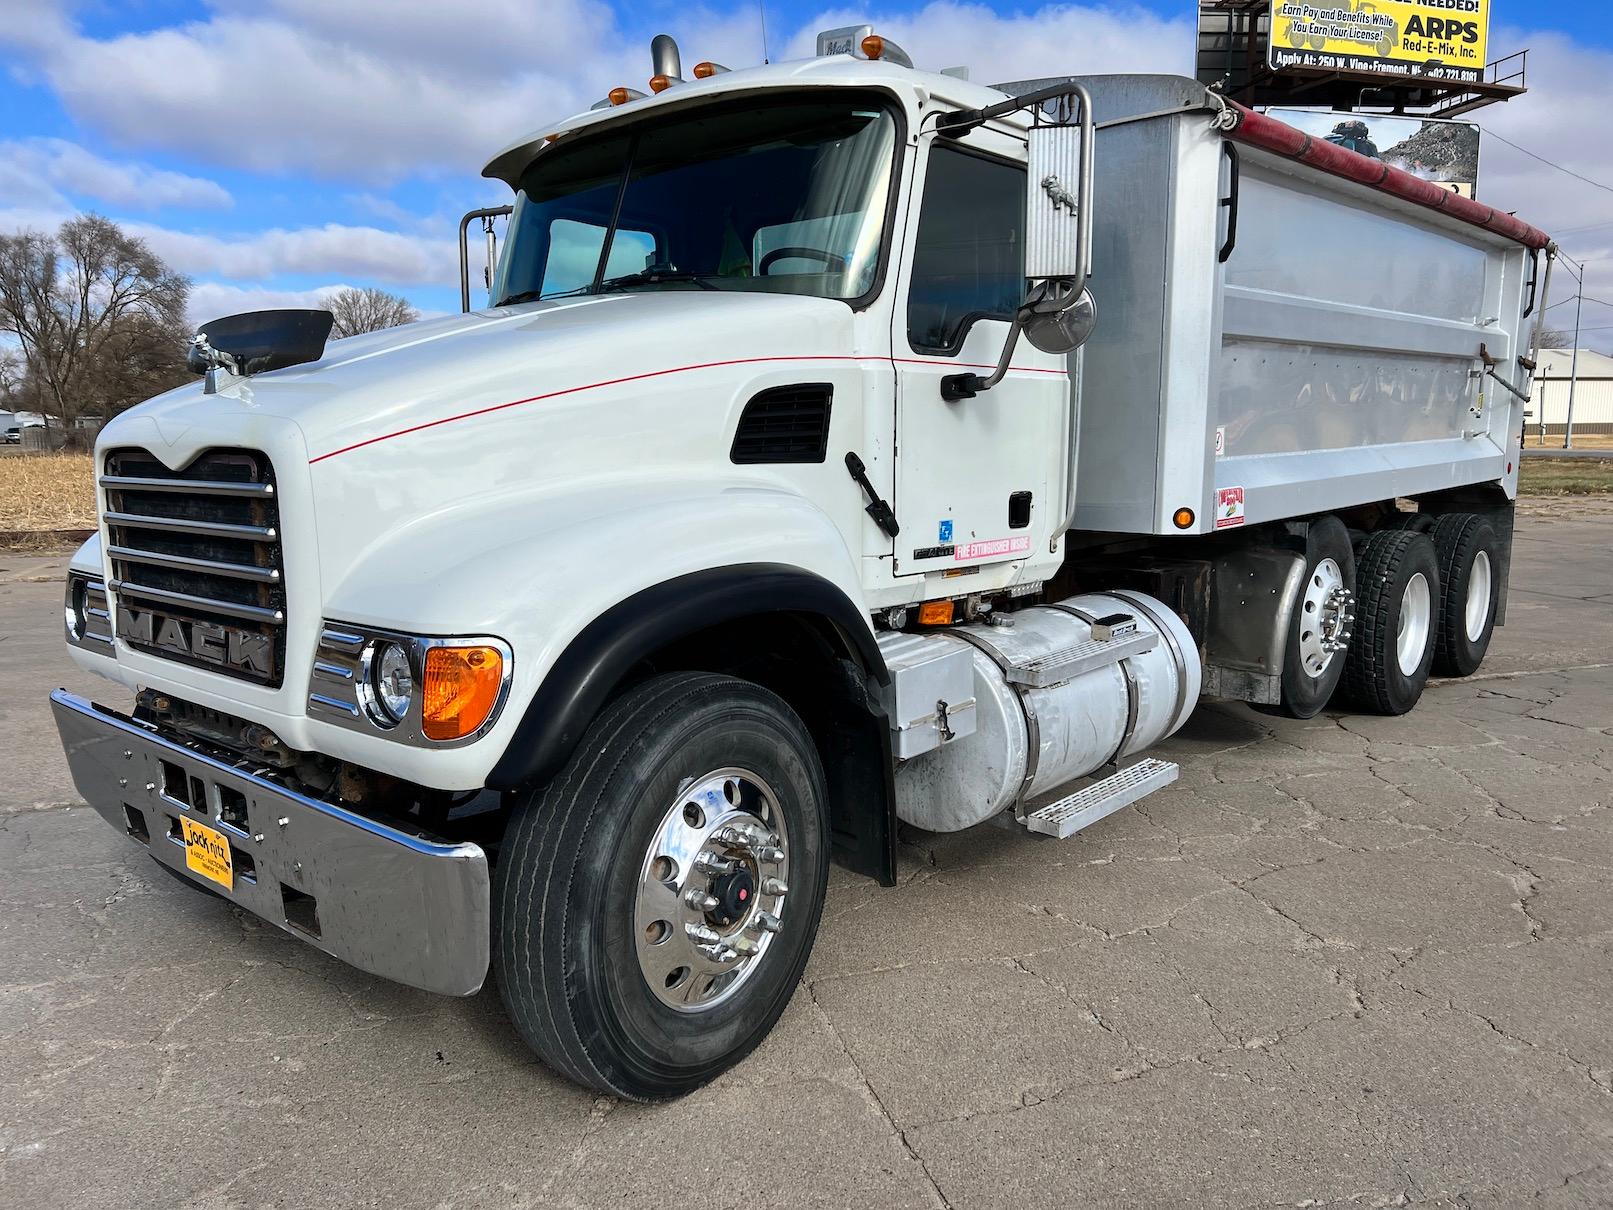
[1268,516,1355,718]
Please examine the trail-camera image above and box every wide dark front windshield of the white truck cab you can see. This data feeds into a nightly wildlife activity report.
[494,94,897,305]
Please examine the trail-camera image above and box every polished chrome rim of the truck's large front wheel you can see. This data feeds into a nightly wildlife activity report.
[634,768,789,1013]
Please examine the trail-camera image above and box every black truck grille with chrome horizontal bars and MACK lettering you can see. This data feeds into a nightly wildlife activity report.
[100,450,286,686]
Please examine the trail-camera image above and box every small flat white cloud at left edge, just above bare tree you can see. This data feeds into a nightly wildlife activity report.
[0,139,232,210]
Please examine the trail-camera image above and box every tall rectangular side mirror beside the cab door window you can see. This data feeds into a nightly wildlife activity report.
[1024,126,1092,294]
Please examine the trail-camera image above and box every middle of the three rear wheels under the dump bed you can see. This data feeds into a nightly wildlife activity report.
[1344,529,1439,715]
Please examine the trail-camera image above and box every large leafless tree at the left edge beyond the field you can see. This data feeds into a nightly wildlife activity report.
[0,215,190,426]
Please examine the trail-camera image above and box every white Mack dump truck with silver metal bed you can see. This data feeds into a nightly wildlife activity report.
[53,27,1553,1099]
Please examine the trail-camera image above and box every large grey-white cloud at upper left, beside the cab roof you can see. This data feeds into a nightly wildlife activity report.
[0,0,642,182]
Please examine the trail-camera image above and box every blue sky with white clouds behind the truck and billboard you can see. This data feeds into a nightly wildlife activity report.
[0,0,1613,347]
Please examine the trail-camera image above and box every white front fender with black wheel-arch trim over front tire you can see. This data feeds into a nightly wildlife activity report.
[311,478,884,789]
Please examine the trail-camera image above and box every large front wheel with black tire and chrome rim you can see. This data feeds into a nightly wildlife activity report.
[494,673,829,1100]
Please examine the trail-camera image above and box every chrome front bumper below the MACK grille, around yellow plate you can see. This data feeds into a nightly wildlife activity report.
[50,689,490,995]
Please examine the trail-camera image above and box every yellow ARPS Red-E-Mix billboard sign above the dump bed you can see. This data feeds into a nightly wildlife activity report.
[1266,0,1490,81]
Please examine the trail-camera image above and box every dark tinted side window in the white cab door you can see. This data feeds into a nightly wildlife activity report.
[908,144,1026,353]
